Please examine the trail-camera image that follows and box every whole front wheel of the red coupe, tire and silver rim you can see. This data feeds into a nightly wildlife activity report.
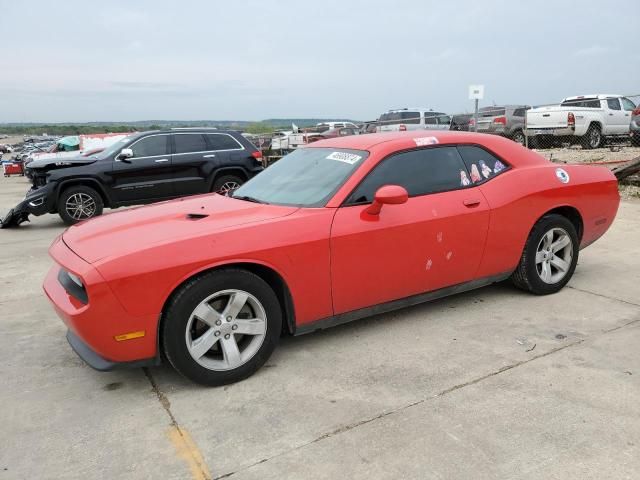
[161,269,282,386]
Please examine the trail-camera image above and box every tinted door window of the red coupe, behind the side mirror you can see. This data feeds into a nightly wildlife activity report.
[347,147,469,204]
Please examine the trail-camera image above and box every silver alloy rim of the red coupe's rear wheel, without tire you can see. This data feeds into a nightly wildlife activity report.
[536,228,573,284]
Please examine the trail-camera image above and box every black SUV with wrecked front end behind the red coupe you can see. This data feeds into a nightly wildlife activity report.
[13,128,263,225]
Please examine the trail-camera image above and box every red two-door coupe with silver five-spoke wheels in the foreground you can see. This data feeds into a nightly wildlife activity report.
[44,131,619,385]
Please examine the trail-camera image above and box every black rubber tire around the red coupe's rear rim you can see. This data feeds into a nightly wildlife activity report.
[511,214,579,295]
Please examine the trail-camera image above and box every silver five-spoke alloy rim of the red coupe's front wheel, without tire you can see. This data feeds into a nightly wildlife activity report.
[185,289,267,371]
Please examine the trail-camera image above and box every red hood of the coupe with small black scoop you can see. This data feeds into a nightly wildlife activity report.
[62,194,298,263]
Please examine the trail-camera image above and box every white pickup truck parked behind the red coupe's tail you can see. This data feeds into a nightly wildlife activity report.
[525,95,636,148]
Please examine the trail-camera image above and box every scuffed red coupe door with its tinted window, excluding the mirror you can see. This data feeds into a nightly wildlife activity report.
[331,146,489,314]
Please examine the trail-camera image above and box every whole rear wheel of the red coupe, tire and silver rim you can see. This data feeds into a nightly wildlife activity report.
[511,214,579,295]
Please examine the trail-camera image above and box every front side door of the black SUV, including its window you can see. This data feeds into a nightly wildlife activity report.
[111,134,173,204]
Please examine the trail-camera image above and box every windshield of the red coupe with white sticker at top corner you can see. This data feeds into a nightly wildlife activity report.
[233,147,369,207]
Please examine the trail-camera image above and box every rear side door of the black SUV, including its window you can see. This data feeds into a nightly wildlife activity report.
[171,132,210,197]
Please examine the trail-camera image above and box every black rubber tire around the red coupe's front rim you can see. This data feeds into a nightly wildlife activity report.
[160,268,282,386]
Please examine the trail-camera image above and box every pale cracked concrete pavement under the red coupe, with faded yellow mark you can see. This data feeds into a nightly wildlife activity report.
[0,173,640,480]
